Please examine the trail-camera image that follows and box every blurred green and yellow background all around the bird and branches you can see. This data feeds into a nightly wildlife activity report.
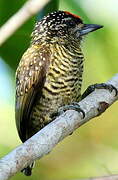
[0,0,118,180]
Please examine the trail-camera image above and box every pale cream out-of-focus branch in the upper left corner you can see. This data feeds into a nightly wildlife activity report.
[0,0,49,46]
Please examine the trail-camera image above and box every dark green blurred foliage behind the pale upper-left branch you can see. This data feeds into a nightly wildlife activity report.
[0,0,58,70]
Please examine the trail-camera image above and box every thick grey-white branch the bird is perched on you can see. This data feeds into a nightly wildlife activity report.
[0,74,118,180]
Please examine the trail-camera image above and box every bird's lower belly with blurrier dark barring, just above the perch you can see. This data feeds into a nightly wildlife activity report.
[27,77,80,137]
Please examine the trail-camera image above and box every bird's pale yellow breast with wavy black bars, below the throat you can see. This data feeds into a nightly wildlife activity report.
[43,45,83,104]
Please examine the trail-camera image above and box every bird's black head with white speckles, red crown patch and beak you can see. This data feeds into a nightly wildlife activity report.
[32,11,103,44]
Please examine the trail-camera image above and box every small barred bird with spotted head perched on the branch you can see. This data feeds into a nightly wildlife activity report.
[15,10,103,176]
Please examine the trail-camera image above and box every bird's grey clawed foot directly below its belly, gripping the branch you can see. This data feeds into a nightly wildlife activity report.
[51,102,85,118]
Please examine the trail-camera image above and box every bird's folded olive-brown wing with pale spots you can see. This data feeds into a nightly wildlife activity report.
[15,46,50,142]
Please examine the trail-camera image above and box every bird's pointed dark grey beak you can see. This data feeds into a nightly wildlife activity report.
[80,24,103,36]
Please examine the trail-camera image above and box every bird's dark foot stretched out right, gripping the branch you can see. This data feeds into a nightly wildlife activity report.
[81,83,118,100]
